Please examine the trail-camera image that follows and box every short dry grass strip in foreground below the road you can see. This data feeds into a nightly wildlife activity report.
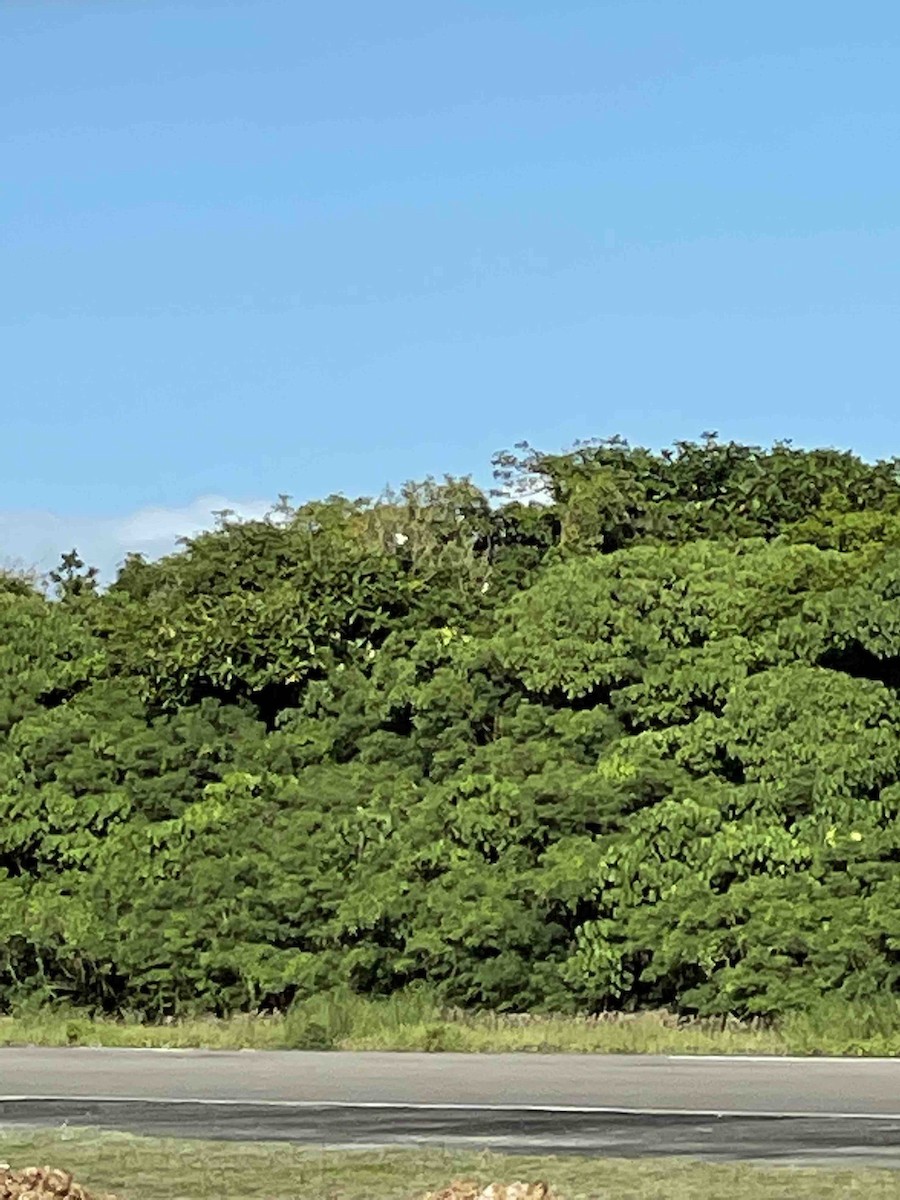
[0,1129,900,1200]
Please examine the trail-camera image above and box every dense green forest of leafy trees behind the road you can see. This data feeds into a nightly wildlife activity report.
[0,434,900,1018]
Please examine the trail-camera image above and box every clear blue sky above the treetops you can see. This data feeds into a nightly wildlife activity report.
[0,0,900,571]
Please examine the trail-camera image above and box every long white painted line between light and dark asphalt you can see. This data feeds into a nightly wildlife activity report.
[0,1096,900,1123]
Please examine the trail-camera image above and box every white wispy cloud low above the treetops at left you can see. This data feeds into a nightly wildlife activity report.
[0,496,271,583]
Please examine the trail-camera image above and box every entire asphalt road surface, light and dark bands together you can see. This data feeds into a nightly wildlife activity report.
[0,1048,900,1168]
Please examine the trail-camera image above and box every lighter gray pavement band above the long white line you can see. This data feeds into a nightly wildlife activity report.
[0,1048,900,1120]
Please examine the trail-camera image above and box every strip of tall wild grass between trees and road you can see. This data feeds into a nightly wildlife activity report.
[0,992,900,1056]
